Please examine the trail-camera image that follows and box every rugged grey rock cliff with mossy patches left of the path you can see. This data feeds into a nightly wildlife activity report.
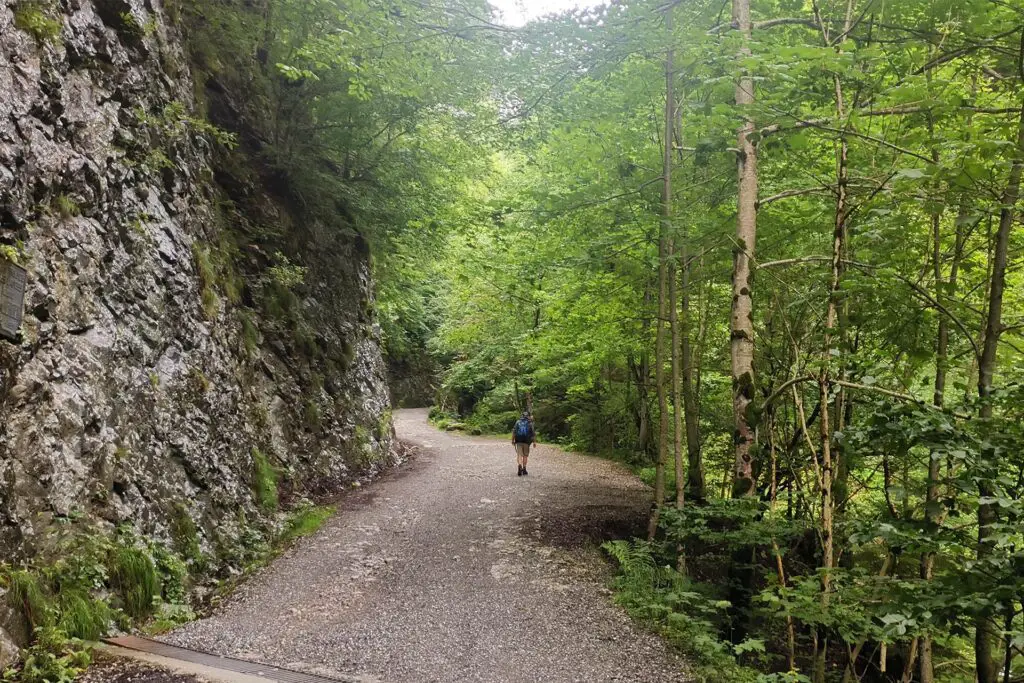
[0,0,392,649]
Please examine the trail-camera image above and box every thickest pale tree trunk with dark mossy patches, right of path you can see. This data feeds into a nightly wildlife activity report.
[729,0,758,498]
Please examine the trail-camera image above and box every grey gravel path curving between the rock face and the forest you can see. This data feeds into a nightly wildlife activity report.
[165,410,690,683]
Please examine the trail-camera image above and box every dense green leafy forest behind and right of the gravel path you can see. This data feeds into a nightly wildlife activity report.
[2,0,1024,683]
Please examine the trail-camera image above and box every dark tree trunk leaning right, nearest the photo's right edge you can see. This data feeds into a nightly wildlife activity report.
[974,94,1024,683]
